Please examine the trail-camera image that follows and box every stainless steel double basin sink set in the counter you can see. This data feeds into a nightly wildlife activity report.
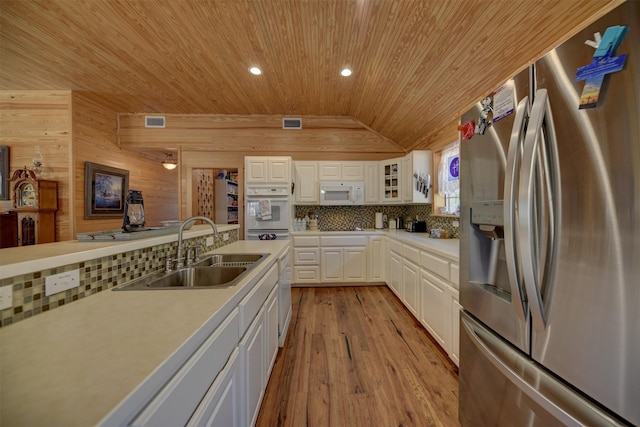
[113,254,267,291]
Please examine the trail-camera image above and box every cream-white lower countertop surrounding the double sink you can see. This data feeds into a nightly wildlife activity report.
[0,241,289,427]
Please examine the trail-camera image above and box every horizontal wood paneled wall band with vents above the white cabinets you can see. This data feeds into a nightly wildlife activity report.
[119,114,404,155]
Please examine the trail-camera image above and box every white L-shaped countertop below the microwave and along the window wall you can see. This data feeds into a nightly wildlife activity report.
[291,228,460,263]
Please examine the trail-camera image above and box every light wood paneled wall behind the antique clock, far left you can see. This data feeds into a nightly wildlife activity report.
[0,90,73,240]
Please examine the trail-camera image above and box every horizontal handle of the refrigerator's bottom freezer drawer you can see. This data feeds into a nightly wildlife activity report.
[460,312,619,426]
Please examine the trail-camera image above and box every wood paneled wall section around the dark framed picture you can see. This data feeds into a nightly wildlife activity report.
[73,92,179,232]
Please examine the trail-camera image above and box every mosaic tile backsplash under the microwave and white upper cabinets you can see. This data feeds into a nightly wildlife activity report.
[295,205,460,239]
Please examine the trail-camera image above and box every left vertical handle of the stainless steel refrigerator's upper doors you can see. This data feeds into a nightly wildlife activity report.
[504,96,531,320]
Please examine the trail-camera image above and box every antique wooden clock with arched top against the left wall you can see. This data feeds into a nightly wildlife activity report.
[11,168,58,246]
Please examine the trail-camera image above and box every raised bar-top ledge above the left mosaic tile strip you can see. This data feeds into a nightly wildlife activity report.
[0,224,239,279]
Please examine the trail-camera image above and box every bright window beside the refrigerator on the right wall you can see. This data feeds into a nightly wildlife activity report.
[433,141,460,216]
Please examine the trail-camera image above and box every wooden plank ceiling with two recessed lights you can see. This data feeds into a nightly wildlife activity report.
[0,0,621,150]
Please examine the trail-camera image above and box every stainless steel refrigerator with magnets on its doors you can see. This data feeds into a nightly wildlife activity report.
[459,1,640,427]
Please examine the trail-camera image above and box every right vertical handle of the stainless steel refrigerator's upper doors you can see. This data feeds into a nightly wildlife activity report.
[517,89,560,331]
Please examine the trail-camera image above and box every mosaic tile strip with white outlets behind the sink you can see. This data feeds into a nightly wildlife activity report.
[0,229,238,327]
